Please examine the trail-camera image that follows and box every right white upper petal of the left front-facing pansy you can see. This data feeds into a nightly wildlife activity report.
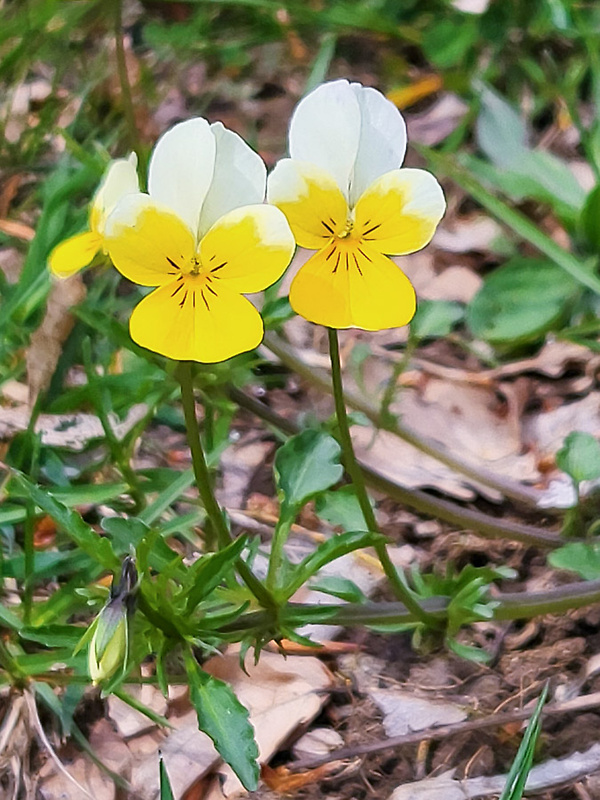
[199,122,267,237]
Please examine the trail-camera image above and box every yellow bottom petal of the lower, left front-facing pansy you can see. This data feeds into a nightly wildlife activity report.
[129,278,263,363]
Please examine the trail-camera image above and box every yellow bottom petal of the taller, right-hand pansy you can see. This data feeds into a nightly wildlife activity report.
[290,243,416,331]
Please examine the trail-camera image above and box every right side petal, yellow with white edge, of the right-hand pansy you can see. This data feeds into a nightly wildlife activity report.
[355,169,446,256]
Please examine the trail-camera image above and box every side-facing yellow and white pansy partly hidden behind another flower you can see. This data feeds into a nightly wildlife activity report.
[48,153,140,278]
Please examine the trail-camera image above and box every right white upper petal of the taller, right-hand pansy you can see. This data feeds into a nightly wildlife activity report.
[350,83,406,205]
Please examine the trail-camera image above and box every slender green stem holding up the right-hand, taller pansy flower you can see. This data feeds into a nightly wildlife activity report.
[327,328,436,625]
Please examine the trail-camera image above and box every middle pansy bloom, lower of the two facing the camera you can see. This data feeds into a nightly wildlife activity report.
[106,118,294,363]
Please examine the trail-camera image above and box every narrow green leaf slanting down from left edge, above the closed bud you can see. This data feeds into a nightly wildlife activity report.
[12,471,121,572]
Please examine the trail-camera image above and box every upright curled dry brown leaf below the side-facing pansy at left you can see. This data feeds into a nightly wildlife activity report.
[26,275,86,407]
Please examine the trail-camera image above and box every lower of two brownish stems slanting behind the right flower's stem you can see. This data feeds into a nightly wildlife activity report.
[229,387,564,549]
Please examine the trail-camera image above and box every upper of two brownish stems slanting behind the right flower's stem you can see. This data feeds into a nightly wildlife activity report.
[264,333,553,514]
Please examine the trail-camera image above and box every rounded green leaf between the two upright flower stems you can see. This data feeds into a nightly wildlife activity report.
[274,430,344,517]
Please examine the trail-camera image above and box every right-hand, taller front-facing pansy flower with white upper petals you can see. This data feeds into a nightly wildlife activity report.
[267,80,445,331]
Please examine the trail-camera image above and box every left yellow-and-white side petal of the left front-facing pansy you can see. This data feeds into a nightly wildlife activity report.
[104,194,196,286]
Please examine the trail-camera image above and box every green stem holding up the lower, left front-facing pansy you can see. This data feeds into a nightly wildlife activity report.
[176,361,275,608]
